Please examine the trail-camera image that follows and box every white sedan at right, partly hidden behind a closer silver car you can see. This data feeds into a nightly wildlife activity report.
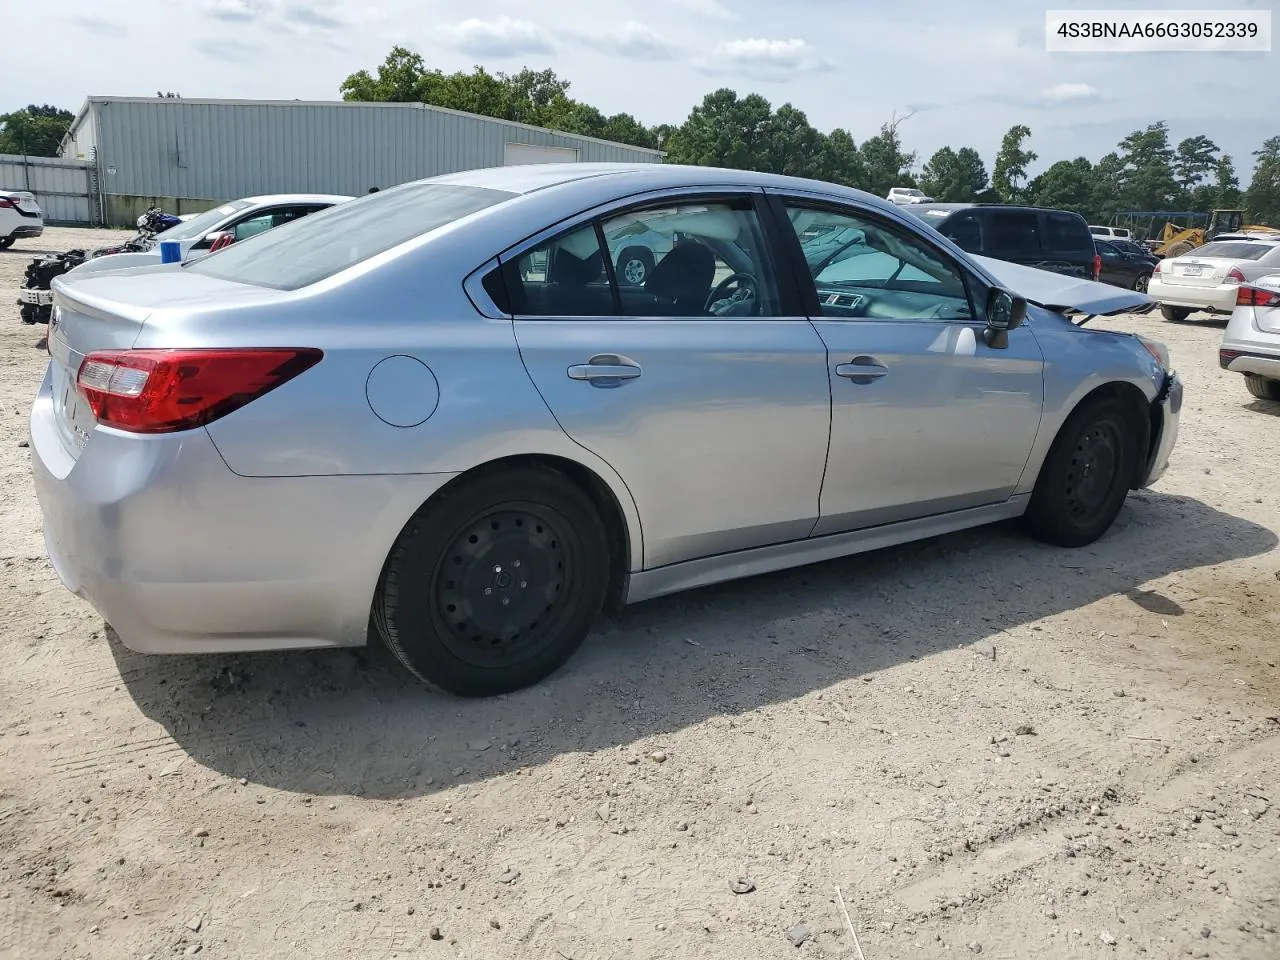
[1147,237,1280,320]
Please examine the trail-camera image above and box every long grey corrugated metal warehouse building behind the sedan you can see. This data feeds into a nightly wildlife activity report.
[52,97,662,225]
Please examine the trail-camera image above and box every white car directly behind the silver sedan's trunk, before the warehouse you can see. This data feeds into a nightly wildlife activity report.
[64,193,351,278]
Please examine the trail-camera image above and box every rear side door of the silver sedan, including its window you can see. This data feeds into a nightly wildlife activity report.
[502,193,831,568]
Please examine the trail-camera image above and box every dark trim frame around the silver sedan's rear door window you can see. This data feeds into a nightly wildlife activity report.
[462,184,809,323]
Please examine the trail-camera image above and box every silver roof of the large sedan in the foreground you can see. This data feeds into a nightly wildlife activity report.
[417,163,901,212]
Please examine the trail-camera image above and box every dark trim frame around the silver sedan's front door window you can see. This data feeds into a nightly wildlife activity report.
[765,189,992,328]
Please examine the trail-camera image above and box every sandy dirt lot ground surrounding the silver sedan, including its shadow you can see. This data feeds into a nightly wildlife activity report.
[0,229,1280,960]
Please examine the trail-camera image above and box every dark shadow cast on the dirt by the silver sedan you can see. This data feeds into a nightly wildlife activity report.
[104,490,1277,797]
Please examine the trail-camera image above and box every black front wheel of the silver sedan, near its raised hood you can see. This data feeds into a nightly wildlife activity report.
[1024,397,1139,547]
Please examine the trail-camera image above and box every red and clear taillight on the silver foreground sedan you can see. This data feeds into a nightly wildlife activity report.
[76,347,324,434]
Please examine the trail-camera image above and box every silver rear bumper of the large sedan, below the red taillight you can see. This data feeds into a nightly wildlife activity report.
[31,366,452,653]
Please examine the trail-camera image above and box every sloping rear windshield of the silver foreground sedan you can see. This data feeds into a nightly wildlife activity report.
[186,183,516,291]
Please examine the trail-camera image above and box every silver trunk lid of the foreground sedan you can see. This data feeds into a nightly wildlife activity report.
[49,264,285,458]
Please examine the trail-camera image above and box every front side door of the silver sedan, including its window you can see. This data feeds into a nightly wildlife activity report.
[774,195,1044,535]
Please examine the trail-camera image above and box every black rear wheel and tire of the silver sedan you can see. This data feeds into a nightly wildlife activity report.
[374,467,609,696]
